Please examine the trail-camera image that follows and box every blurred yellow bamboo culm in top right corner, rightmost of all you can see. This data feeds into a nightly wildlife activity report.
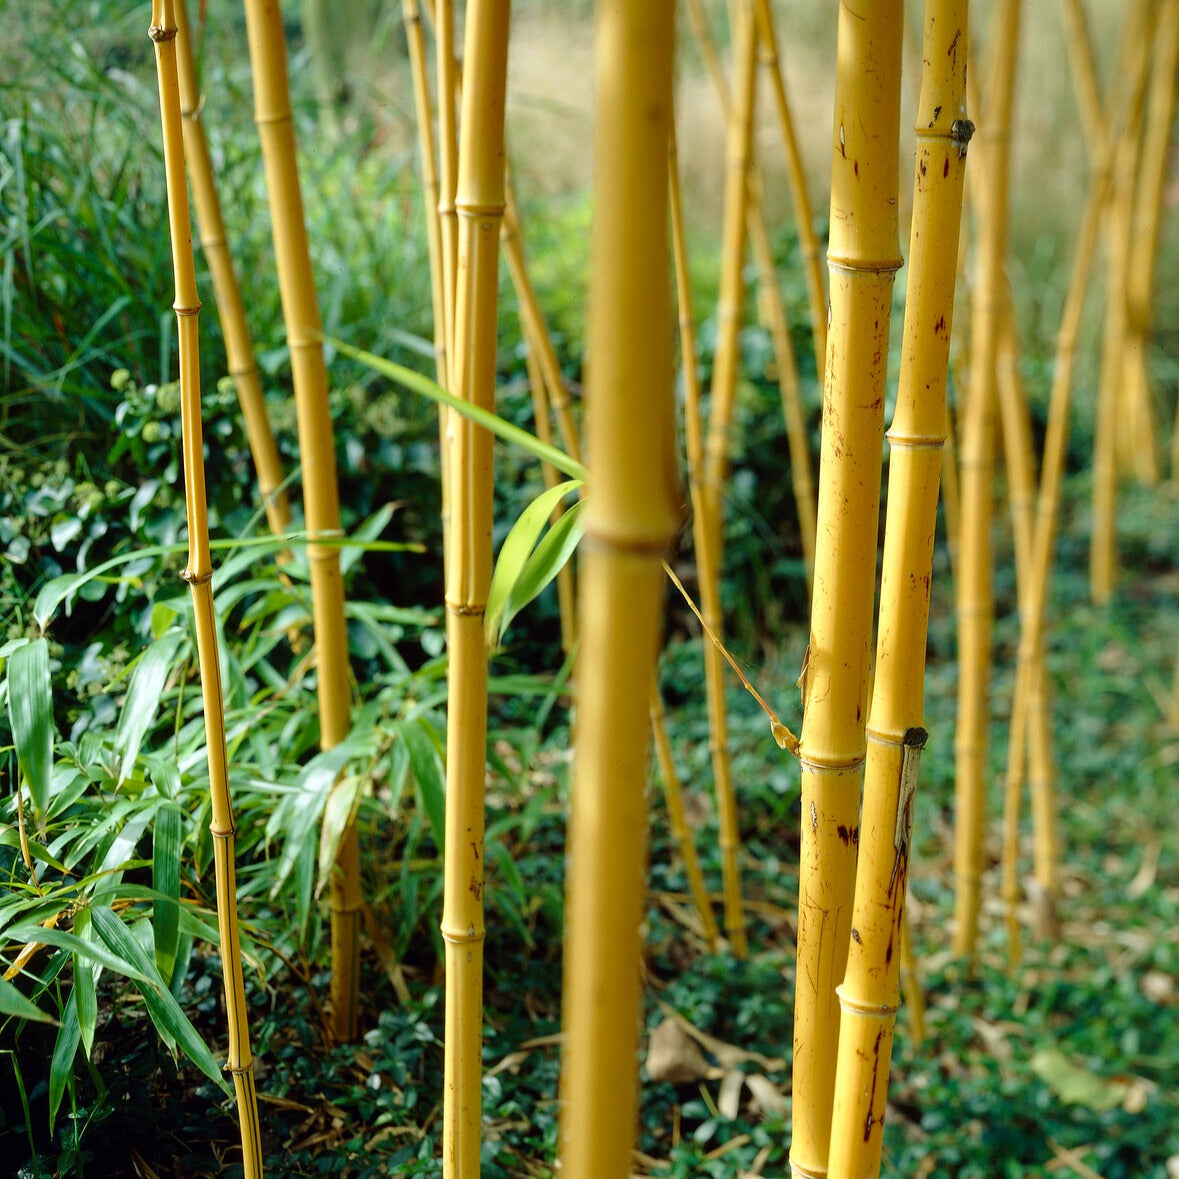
[1122,0,1179,486]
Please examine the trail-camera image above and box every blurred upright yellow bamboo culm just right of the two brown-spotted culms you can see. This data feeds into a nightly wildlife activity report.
[954,0,1020,957]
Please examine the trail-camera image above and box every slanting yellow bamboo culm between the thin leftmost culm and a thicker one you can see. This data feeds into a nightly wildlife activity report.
[174,0,291,536]
